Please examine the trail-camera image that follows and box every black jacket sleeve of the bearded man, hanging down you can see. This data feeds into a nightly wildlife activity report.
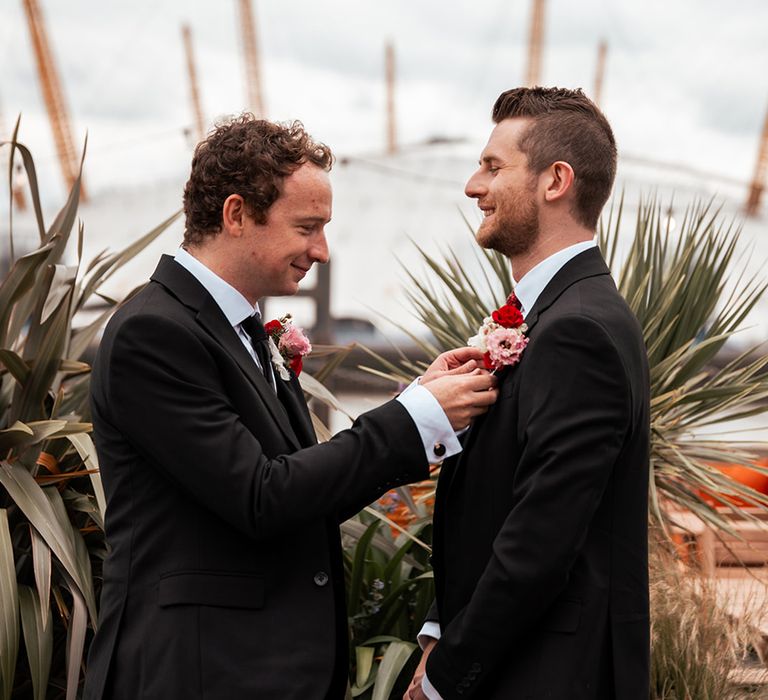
[427,316,632,699]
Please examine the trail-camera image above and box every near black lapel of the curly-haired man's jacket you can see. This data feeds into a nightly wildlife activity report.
[152,255,301,449]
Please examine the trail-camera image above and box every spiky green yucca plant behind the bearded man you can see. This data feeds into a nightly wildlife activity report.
[369,196,768,532]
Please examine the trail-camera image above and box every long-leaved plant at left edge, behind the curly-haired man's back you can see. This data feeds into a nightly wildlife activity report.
[0,129,177,700]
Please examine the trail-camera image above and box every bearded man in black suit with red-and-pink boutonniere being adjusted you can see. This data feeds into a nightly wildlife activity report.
[405,87,649,700]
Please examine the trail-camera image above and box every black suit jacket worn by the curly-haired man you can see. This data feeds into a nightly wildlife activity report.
[84,257,428,700]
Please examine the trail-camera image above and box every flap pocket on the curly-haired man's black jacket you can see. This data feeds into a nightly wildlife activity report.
[157,571,264,610]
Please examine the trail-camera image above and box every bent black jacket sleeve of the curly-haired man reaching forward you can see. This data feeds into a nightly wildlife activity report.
[104,314,428,538]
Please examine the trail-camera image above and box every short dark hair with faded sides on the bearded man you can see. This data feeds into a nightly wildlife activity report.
[493,87,616,229]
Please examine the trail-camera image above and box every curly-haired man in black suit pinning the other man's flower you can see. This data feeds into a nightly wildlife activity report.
[84,115,496,700]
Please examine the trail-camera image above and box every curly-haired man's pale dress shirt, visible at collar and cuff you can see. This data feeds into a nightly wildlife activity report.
[175,248,461,464]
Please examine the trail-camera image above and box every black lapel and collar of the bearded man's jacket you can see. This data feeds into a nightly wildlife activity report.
[448,248,611,498]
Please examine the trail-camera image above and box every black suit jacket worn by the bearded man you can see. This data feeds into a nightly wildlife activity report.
[427,249,649,700]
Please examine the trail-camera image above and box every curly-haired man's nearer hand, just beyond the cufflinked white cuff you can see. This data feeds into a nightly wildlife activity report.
[422,369,499,430]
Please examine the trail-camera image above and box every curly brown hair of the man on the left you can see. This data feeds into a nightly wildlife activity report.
[184,113,333,246]
